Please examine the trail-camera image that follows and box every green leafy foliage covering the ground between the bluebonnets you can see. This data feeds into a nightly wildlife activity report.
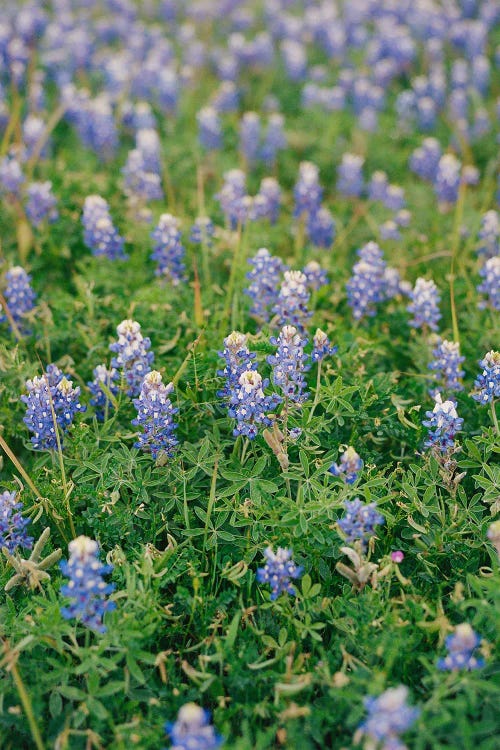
[0,5,500,750]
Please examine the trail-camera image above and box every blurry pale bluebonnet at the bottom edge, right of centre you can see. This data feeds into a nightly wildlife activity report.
[358,685,420,750]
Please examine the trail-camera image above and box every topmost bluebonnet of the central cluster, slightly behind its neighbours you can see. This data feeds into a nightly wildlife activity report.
[245,247,286,322]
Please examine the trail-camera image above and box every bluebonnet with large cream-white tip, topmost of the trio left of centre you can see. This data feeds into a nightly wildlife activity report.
[109,320,154,396]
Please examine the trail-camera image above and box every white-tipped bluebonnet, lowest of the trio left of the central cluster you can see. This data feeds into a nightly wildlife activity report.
[132,370,179,459]
